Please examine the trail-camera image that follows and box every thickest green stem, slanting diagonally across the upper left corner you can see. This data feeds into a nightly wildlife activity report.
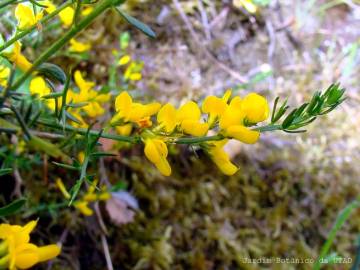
[11,0,119,90]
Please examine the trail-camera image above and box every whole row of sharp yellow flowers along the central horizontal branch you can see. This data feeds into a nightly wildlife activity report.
[110,90,269,176]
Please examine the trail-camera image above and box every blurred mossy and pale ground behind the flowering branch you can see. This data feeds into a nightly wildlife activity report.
[2,0,360,269]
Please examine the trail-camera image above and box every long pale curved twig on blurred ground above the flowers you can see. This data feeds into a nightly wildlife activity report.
[172,0,248,83]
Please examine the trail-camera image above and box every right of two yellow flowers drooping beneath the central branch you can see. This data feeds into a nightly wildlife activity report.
[207,139,238,175]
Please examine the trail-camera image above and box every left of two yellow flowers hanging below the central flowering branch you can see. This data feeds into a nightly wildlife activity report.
[144,138,171,176]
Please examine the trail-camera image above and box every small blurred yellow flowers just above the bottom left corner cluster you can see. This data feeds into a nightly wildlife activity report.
[55,178,111,216]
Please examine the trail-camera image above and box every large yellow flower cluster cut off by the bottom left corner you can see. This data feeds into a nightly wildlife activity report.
[0,221,61,270]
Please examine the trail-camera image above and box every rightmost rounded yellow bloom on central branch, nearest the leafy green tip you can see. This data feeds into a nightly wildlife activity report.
[219,93,269,144]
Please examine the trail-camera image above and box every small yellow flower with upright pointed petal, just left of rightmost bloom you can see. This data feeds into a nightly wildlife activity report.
[202,90,231,126]
